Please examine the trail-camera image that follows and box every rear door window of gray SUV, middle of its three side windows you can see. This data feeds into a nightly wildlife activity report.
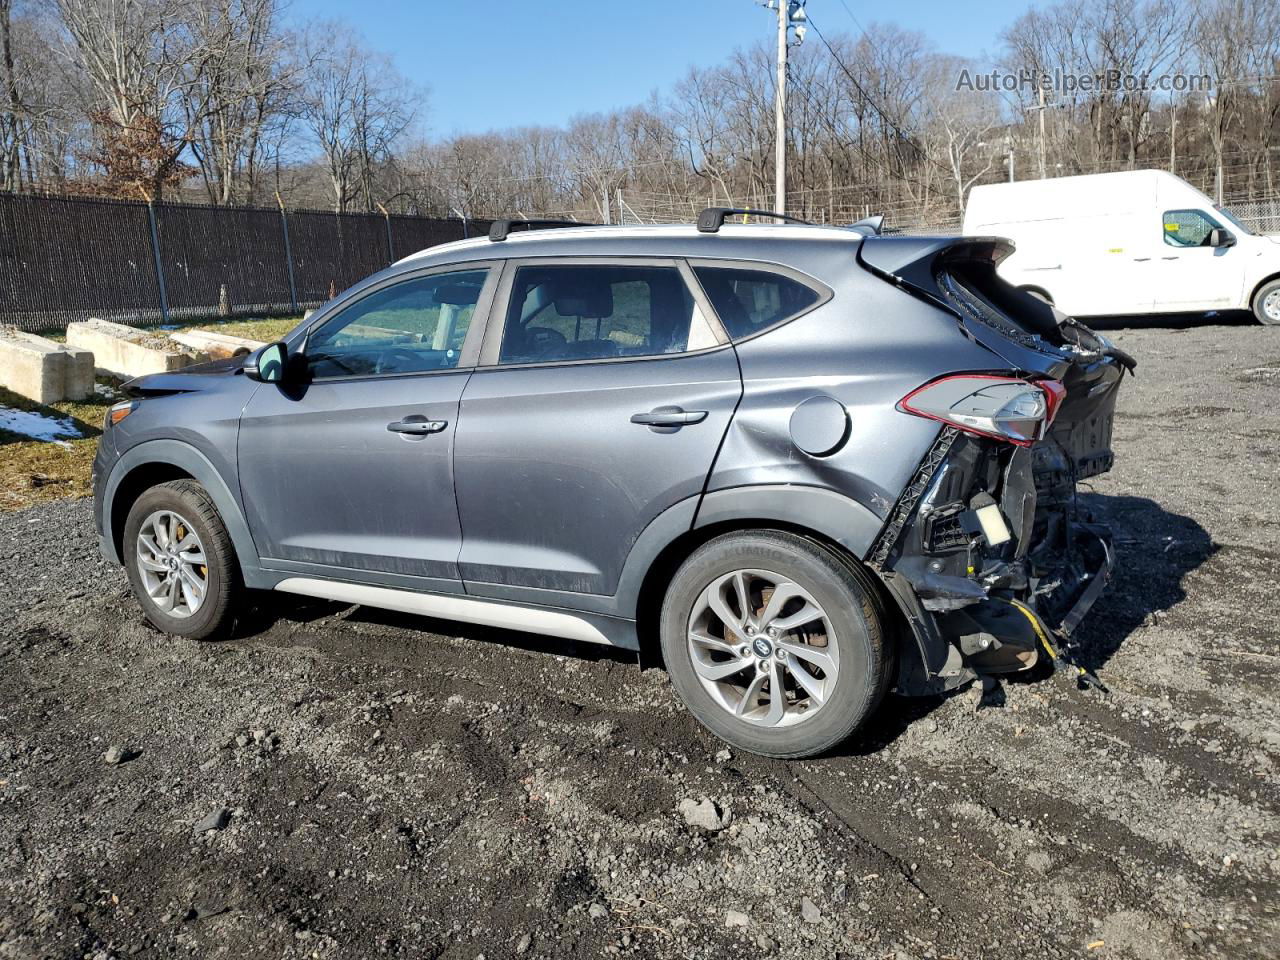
[498,264,716,364]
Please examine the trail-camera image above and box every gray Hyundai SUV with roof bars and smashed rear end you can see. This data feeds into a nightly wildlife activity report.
[95,209,1133,756]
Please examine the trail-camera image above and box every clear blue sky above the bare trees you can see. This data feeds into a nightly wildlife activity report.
[289,0,1029,136]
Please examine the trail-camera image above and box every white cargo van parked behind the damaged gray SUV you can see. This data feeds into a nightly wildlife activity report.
[964,170,1280,324]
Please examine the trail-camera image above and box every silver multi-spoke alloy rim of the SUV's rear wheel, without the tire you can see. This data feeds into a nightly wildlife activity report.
[689,570,840,727]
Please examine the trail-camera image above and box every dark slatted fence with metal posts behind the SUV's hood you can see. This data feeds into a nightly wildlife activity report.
[0,193,489,330]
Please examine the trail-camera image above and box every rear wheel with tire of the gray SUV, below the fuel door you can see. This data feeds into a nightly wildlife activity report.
[662,531,888,758]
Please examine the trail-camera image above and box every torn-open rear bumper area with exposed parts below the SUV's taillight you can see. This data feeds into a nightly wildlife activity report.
[869,419,1114,695]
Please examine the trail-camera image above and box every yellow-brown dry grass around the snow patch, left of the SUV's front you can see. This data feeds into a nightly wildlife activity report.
[0,378,119,511]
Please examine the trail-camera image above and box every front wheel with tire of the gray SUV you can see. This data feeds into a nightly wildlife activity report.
[122,480,241,640]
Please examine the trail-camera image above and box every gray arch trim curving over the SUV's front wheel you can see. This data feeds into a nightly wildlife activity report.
[101,440,272,589]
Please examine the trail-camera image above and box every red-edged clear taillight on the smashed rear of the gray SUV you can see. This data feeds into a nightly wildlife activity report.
[897,374,1066,447]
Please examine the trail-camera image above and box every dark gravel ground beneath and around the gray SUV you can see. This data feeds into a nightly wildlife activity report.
[0,324,1280,960]
